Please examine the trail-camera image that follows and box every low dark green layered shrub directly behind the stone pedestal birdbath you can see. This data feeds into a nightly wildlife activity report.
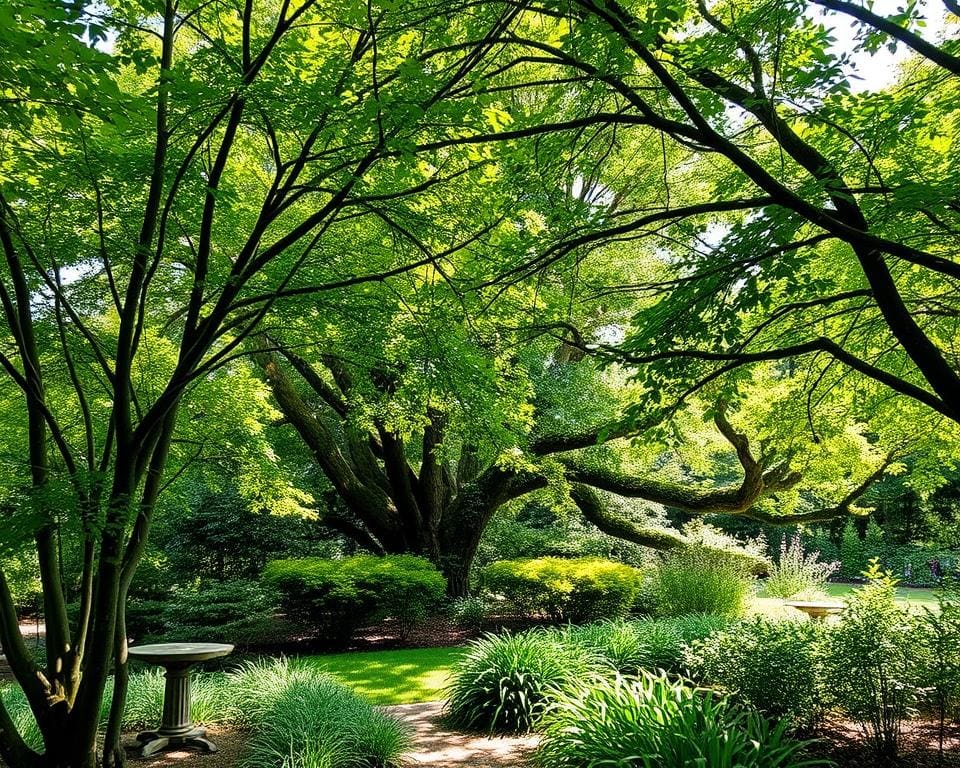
[160,580,278,645]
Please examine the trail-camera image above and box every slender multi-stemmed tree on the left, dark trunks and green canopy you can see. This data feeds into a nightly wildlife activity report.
[0,0,564,768]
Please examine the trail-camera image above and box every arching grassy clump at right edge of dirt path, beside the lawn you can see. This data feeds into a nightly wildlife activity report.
[447,629,592,733]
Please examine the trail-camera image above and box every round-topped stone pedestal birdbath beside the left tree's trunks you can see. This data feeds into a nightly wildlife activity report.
[129,643,233,757]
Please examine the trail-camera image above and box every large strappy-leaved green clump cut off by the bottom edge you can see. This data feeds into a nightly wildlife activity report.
[538,673,823,768]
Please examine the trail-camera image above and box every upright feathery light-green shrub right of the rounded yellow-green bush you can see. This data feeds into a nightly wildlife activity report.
[647,546,753,616]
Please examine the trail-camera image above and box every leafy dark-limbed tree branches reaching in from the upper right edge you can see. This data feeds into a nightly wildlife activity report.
[480,0,960,430]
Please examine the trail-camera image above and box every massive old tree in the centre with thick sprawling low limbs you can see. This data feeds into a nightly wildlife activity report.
[253,270,894,595]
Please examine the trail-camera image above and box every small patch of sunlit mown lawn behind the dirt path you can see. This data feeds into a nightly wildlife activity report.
[305,648,462,704]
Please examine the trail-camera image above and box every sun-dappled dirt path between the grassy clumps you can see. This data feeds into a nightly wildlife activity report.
[385,701,537,768]
